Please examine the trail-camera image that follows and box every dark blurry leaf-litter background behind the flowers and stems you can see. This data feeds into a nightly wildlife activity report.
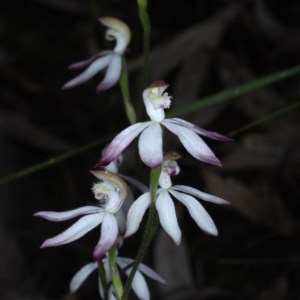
[0,0,300,300]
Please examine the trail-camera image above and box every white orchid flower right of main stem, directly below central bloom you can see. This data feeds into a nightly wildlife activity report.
[125,159,228,245]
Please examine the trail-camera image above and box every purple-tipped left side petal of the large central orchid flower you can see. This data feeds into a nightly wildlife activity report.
[95,121,151,168]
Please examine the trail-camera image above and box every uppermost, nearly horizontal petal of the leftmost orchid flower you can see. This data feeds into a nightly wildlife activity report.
[34,206,103,222]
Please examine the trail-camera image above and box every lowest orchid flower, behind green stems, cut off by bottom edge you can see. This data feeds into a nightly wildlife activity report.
[70,256,166,300]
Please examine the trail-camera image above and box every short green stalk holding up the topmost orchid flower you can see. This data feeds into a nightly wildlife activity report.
[120,57,136,124]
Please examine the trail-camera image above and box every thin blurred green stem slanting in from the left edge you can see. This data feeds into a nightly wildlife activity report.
[0,137,110,186]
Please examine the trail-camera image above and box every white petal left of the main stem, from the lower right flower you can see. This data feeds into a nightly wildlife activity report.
[124,192,150,238]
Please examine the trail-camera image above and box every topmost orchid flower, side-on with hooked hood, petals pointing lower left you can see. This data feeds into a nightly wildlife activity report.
[63,17,131,93]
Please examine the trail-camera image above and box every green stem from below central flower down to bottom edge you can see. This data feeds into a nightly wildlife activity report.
[122,166,161,300]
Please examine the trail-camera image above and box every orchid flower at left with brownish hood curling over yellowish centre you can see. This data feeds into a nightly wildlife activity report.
[35,171,127,260]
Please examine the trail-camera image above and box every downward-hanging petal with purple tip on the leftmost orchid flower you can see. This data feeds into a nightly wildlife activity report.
[93,213,119,261]
